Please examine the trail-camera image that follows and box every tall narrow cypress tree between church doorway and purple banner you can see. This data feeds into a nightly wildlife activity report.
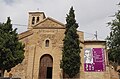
[61,7,81,78]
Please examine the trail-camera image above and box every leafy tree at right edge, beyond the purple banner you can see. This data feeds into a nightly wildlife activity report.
[107,4,120,70]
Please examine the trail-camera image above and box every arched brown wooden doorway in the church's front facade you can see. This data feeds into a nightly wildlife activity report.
[39,54,53,79]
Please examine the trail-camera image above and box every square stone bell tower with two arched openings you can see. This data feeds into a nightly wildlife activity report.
[28,12,45,30]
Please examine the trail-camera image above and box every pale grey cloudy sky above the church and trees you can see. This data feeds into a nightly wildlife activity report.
[0,0,120,40]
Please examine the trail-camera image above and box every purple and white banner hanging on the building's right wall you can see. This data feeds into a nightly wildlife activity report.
[84,48,105,72]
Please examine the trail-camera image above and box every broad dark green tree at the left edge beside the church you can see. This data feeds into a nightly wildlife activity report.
[0,17,24,76]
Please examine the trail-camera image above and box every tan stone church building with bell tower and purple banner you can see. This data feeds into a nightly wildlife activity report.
[5,12,110,79]
